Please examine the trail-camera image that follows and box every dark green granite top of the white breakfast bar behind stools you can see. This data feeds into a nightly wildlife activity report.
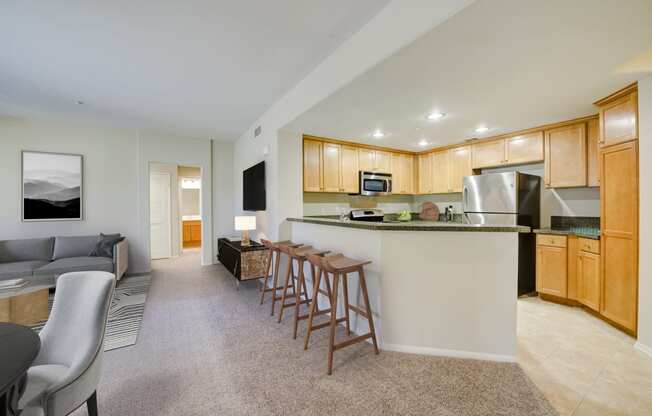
[287,217,530,233]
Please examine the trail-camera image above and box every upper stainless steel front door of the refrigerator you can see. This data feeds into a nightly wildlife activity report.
[462,172,518,214]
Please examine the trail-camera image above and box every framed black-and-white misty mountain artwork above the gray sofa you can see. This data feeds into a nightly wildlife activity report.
[22,151,84,221]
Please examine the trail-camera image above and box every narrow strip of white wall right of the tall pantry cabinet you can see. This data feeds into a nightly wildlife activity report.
[637,76,652,355]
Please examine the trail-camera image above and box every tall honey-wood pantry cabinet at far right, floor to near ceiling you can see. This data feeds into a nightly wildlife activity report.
[595,84,639,334]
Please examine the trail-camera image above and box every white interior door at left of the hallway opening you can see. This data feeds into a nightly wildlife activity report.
[149,172,172,259]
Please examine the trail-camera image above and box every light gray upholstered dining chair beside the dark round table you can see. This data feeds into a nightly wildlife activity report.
[19,271,115,416]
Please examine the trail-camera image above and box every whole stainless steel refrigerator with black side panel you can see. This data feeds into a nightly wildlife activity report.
[462,172,541,296]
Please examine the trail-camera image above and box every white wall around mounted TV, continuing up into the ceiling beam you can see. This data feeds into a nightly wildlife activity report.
[233,0,472,239]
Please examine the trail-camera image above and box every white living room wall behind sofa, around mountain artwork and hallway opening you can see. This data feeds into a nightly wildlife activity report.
[0,116,227,273]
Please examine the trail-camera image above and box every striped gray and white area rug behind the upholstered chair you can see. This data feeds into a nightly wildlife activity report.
[32,275,152,351]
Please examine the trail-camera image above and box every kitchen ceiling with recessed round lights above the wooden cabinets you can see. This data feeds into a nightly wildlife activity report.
[287,0,652,150]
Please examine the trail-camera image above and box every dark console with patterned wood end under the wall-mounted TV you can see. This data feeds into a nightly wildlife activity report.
[217,238,269,285]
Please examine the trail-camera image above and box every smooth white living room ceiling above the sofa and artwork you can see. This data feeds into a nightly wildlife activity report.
[0,0,388,140]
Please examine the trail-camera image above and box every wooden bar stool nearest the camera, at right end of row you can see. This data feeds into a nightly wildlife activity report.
[308,254,379,375]
